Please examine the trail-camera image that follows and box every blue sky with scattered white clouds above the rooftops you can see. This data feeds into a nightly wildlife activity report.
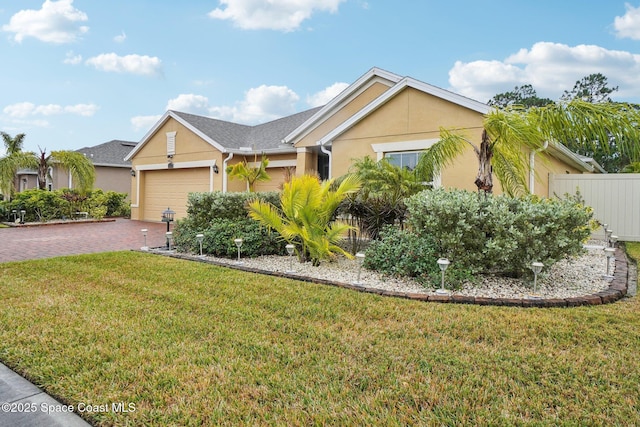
[0,0,640,154]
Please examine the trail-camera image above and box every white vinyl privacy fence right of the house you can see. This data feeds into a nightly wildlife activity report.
[549,173,640,242]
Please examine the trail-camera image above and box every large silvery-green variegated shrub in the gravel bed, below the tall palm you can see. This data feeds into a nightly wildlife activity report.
[407,189,593,276]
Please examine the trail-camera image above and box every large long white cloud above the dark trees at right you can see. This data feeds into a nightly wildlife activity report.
[449,42,640,102]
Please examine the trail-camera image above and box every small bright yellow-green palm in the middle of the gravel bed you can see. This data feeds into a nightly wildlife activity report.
[249,175,360,266]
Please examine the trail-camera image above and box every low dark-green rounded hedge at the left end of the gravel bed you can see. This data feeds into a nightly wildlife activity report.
[173,218,286,258]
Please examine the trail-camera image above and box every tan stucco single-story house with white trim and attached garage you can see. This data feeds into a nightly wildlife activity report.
[125,68,599,221]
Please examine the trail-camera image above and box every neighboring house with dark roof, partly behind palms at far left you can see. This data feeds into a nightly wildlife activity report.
[9,140,137,199]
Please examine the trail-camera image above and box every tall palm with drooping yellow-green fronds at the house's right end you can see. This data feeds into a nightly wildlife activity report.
[417,100,640,194]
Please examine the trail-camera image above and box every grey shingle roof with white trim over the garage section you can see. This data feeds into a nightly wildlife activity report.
[125,107,321,160]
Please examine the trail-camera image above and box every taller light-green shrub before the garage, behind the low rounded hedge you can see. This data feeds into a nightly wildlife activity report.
[187,191,280,230]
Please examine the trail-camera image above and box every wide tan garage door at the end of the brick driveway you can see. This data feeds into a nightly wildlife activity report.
[142,168,209,221]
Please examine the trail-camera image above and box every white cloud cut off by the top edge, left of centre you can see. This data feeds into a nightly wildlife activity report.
[209,0,345,31]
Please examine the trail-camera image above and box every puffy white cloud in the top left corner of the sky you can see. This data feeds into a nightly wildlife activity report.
[2,0,89,44]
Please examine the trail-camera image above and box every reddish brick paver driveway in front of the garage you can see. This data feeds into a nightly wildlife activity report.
[0,218,173,262]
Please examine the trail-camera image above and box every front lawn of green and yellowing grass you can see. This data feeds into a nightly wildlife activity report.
[0,252,640,426]
